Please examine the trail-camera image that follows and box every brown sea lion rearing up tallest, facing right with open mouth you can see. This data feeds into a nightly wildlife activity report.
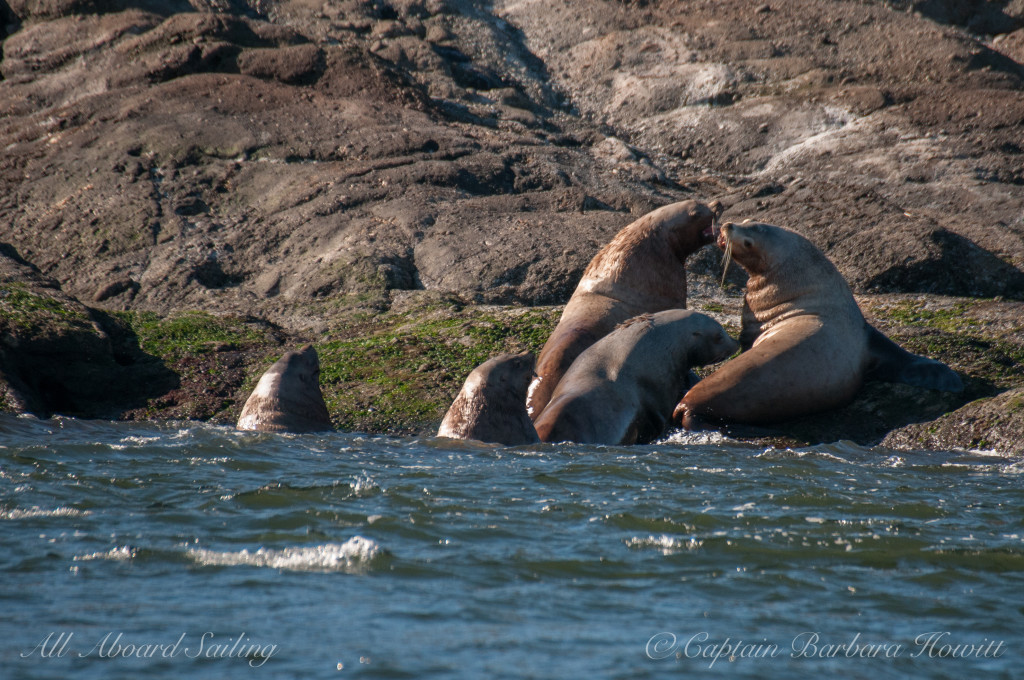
[526,201,722,421]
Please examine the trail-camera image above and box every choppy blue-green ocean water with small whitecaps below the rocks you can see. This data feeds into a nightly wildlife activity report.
[0,416,1024,680]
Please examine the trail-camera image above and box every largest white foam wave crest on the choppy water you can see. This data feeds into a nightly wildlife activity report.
[187,536,384,573]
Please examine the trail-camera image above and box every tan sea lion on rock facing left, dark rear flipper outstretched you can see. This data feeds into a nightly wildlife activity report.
[673,220,964,429]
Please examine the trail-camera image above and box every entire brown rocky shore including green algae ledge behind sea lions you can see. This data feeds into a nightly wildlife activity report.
[0,0,1024,453]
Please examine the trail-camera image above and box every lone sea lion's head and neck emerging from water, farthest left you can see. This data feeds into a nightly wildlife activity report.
[236,345,332,432]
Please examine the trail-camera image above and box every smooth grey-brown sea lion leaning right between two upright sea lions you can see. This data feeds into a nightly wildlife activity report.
[536,309,739,444]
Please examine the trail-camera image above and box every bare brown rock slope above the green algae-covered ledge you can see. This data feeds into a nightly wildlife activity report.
[0,0,1024,436]
